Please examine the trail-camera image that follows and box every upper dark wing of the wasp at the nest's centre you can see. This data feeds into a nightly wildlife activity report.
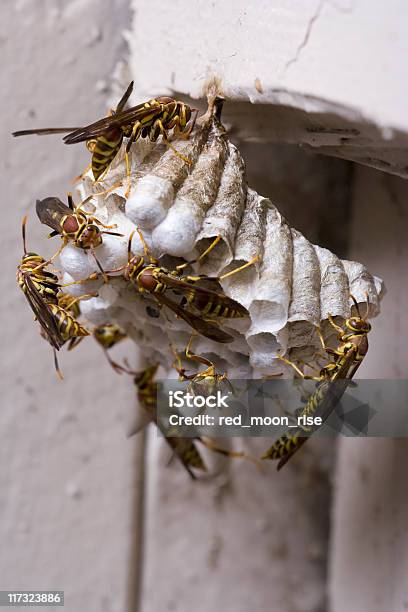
[157,272,249,317]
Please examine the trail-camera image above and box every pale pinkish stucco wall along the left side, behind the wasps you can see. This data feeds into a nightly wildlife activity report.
[0,0,138,612]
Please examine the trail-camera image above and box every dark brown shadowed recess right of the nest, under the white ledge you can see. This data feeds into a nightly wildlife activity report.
[238,142,354,258]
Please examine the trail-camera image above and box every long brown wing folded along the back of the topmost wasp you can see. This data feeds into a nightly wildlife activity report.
[64,103,162,144]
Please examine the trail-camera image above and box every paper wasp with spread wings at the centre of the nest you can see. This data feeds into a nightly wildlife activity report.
[105,229,258,342]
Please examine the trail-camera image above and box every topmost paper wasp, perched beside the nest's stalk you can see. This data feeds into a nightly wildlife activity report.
[13,81,198,191]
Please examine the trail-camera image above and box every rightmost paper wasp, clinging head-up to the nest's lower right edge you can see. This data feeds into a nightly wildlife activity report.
[262,296,371,470]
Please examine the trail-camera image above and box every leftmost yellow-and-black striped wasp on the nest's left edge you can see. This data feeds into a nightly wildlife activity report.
[17,217,89,377]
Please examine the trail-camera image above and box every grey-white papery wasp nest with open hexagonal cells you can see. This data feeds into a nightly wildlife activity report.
[61,99,383,378]
